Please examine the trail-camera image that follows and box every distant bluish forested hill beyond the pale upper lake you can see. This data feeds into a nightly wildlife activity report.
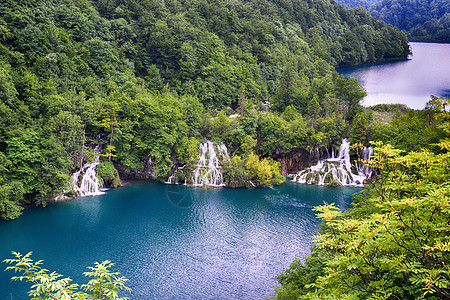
[337,0,450,43]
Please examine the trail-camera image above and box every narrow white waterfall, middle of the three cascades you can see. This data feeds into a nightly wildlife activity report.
[191,141,230,187]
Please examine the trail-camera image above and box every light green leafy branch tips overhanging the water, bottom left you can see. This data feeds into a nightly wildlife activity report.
[3,251,131,300]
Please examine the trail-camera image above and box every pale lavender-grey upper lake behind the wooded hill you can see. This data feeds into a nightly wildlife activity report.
[338,42,450,109]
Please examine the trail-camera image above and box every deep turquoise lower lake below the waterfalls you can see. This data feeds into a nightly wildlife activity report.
[0,182,360,300]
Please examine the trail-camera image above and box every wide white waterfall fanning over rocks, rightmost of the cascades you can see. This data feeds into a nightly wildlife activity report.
[292,139,373,186]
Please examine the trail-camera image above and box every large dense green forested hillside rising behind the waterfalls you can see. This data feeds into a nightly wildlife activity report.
[0,0,409,219]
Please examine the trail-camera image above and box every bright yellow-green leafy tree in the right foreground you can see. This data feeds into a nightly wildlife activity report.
[314,144,450,299]
